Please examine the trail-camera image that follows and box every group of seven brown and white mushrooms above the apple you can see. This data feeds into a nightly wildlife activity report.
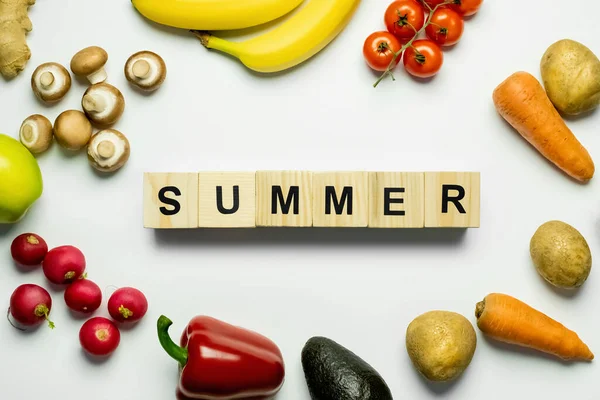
[19,46,167,172]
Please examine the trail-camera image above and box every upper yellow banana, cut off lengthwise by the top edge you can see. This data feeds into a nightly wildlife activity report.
[131,0,303,31]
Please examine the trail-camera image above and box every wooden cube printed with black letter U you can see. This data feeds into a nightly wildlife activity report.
[198,172,256,228]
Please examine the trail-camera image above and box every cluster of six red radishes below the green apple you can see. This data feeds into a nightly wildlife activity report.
[8,233,148,356]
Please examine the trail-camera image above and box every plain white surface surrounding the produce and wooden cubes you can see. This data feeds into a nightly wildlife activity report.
[0,0,600,400]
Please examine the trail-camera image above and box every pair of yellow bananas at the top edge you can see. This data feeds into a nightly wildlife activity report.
[131,0,360,73]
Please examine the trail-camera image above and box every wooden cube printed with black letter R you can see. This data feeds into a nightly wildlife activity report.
[425,172,480,228]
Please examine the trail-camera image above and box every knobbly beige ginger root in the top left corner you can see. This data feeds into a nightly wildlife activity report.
[0,0,36,79]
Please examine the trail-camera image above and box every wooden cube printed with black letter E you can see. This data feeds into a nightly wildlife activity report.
[369,172,425,228]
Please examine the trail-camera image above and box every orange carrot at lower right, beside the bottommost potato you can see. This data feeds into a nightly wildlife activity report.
[475,293,594,361]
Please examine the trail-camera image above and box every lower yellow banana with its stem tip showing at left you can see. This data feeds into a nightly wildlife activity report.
[193,0,360,73]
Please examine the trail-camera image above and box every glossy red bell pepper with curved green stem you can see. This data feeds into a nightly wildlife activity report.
[157,315,285,400]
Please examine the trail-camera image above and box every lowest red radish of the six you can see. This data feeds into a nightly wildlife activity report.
[79,317,121,356]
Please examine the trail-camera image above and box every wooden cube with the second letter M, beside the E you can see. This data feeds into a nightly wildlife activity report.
[313,172,369,228]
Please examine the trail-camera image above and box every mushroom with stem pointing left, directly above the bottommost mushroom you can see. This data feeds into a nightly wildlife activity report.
[81,83,125,128]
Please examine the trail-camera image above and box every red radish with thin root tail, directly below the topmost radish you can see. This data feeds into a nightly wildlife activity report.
[8,283,54,329]
